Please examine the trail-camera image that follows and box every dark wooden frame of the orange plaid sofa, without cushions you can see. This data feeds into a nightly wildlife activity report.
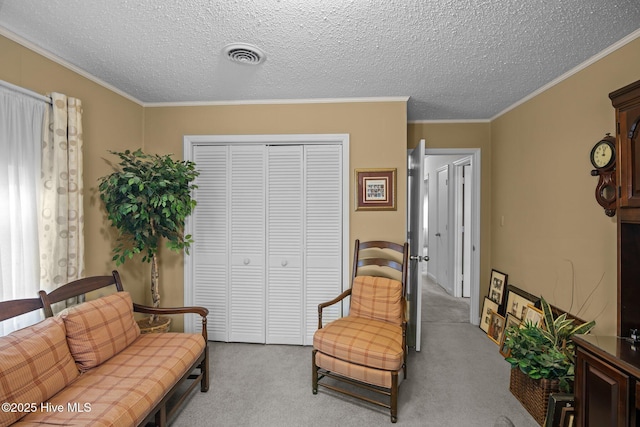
[0,270,209,427]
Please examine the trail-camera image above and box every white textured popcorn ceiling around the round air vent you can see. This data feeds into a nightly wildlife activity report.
[0,0,640,120]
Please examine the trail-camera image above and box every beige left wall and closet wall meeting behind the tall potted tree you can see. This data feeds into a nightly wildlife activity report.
[0,32,407,329]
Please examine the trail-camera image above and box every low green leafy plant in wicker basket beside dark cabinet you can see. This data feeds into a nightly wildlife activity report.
[504,298,595,424]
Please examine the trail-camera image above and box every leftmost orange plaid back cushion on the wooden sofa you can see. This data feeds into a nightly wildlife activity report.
[0,317,78,426]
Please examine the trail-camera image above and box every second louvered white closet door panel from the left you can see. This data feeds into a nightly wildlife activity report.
[229,146,265,343]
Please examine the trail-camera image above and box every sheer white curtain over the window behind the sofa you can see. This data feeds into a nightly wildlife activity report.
[0,87,47,335]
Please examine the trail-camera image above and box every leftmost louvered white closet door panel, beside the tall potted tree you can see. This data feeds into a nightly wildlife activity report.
[190,145,229,341]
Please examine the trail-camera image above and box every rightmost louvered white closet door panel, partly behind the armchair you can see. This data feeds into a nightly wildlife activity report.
[304,145,342,345]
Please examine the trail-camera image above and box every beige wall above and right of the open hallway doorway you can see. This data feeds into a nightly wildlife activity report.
[407,122,491,303]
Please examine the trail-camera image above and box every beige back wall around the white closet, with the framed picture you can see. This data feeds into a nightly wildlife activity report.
[144,101,407,330]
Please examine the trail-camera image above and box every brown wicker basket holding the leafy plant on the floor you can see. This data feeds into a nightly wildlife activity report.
[509,368,560,425]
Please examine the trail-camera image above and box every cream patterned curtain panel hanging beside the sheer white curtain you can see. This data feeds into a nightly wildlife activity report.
[39,93,84,291]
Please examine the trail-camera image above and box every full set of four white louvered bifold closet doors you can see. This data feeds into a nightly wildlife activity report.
[191,139,343,345]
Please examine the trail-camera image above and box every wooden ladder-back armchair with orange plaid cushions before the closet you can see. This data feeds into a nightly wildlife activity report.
[312,240,409,423]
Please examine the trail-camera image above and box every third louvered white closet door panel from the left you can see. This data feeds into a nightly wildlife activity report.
[266,146,304,344]
